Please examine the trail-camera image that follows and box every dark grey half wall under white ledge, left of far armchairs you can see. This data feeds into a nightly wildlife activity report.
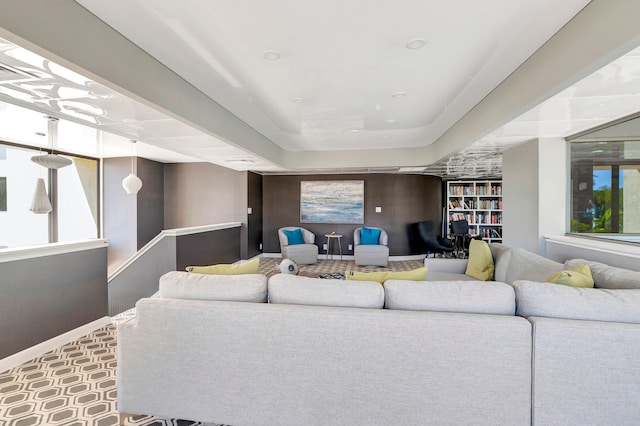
[176,227,241,271]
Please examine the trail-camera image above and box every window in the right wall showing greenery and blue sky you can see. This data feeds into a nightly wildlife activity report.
[571,141,640,242]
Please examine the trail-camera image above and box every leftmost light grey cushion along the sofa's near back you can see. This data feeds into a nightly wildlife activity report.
[160,271,267,303]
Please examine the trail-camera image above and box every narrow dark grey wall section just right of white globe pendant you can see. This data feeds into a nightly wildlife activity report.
[136,158,164,250]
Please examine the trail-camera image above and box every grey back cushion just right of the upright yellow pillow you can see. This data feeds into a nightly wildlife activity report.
[505,248,564,284]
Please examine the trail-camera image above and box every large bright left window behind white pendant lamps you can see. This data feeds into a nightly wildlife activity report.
[0,102,100,248]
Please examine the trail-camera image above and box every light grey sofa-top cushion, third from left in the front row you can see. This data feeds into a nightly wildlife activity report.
[384,280,516,315]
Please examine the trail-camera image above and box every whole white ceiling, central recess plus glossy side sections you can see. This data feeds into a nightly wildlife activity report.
[0,0,640,177]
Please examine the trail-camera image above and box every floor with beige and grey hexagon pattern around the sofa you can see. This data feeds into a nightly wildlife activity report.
[0,258,423,426]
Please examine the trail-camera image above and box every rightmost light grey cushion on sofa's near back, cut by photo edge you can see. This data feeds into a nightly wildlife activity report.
[513,281,640,324]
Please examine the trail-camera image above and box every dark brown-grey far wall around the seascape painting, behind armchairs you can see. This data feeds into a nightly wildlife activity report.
[263,174,442,256]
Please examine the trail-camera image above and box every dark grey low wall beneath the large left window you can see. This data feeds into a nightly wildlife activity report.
[0,247,108,358]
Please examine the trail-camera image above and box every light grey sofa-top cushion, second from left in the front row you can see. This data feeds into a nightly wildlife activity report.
[268,274,384,309]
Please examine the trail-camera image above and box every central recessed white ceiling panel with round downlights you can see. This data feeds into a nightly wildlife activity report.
[72,0,588,151]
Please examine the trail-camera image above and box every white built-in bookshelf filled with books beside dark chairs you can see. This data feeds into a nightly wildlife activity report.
[446,180,502,242]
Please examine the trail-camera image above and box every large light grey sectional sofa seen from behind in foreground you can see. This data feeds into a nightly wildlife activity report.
[118,246,640,426]
